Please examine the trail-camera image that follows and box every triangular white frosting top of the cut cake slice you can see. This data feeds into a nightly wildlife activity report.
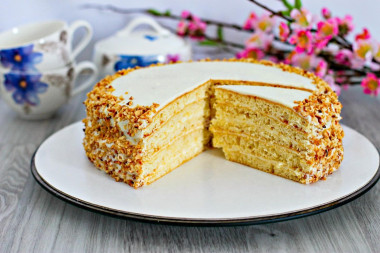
[216,85,311,108]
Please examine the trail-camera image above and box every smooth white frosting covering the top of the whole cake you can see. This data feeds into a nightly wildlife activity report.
[111,62,316,110]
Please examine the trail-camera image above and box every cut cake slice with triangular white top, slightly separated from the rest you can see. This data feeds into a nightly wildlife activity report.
[210,85,343,183]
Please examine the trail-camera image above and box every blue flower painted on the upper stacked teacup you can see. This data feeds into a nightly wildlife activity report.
[0,44,42,71]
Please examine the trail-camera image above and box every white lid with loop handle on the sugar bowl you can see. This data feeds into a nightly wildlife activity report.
[95,16,190,55]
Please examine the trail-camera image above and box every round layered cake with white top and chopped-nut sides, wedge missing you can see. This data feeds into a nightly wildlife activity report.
[83,59,344,188]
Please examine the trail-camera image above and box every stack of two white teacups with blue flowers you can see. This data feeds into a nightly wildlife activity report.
[0,20,98,119]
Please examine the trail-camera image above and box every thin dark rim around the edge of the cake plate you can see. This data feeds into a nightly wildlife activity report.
[30,121,380,226]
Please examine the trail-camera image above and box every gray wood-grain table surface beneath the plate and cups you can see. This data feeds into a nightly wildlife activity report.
[0,54,380,253]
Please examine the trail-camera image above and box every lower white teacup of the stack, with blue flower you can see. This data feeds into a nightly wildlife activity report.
[0,61,98,119]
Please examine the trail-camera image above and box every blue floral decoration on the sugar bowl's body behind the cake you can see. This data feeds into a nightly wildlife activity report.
[114,55,165,71]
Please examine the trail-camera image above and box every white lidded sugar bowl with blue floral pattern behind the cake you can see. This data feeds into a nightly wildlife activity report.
[94,16,191,77]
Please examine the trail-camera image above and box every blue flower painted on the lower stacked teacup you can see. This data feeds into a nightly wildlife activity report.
[4,73,48,106]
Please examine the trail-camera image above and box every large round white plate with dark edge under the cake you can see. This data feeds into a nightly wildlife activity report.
[32,122,380,225]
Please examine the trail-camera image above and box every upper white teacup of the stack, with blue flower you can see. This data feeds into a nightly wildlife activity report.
[0,20,92,71]
